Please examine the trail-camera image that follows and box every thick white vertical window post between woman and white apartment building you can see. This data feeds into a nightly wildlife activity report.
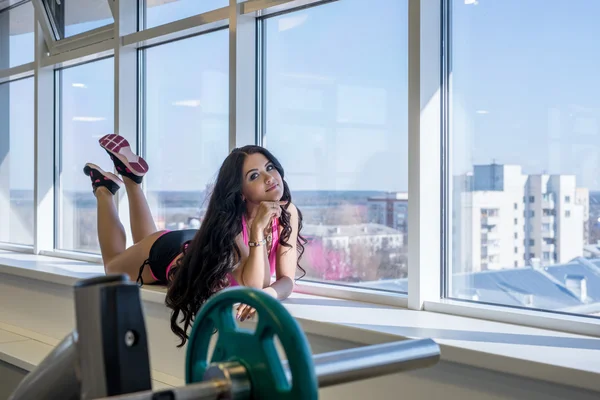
[408,0,443,310]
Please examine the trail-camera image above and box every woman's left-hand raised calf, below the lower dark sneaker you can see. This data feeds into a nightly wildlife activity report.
[94,186,126,266]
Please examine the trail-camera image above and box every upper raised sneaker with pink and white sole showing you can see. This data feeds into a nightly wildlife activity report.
[99,134,148,183]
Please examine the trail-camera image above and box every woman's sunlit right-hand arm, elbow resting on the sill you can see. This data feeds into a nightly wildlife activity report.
[264,204,298,300]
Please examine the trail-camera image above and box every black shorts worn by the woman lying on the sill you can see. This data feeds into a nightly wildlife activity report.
[138,229,198,285]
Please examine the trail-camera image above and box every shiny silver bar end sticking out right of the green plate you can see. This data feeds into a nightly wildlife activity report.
[284,339,440,388]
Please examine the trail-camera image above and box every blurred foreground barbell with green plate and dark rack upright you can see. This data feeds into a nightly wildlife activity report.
[9,275,440,400]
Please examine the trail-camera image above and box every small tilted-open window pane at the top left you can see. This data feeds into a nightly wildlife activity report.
[43,0,114,40]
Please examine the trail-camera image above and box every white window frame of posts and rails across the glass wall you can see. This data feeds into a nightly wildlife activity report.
[0,0,600,336]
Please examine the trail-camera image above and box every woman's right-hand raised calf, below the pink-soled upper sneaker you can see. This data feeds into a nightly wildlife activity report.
[123,176,157,243]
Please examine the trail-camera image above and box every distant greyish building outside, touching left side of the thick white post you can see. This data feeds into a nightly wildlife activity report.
[367,192,408,246]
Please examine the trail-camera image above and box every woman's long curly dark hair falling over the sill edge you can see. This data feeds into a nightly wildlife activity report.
[165,146,306,347]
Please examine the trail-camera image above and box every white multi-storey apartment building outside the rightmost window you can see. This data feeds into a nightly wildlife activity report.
[452,164,589,273]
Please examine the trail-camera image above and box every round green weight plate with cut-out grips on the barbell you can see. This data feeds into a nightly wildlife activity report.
[186,287,319,400]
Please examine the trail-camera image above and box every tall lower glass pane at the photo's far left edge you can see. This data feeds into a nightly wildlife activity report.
[0,78,34,245]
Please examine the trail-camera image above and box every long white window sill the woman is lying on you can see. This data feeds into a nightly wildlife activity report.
[0,251,600,392]
